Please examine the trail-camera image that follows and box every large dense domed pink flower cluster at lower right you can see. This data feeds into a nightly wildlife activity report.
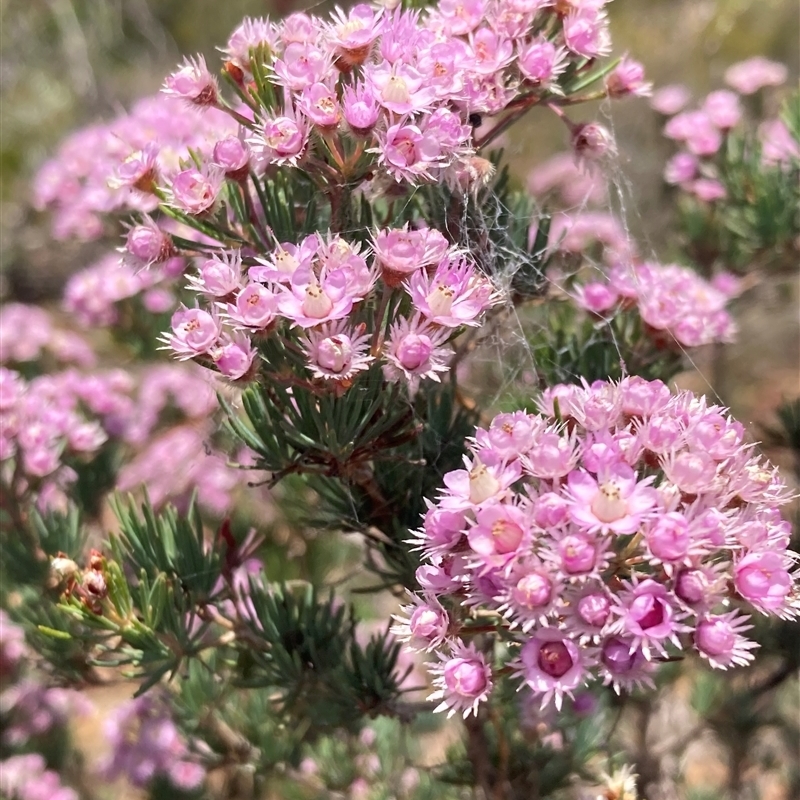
[395,377,800,716]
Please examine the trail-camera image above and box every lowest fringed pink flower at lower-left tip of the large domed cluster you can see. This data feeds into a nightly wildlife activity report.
[428,642,492,718]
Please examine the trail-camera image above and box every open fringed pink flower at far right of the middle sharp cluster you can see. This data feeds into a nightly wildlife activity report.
[406,255,495,328]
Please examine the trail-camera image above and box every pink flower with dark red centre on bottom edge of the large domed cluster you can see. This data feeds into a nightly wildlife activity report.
[518,628,586,710]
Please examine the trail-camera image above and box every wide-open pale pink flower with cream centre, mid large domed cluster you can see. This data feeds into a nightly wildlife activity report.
[567,463,657,534]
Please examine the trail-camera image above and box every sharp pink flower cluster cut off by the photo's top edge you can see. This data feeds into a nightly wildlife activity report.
[188,0,624,186]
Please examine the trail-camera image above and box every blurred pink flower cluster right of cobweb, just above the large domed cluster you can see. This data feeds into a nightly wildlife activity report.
[572,261,738,347]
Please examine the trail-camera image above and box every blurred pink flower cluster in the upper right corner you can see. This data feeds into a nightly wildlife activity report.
[654,57,800,203]
